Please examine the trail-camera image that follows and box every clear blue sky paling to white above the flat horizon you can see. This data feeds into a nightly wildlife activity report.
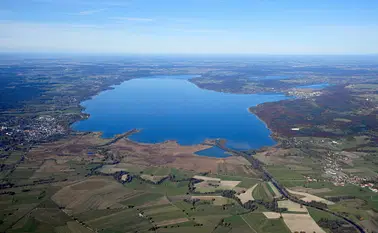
[0,0,378,55]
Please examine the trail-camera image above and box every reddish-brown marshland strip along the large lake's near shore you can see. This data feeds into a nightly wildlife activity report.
[27,133,248,173]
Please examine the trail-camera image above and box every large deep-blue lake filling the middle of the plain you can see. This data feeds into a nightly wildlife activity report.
[72,76,288,155]
